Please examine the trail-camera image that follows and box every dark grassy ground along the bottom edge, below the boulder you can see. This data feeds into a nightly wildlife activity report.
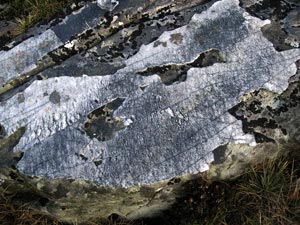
[0,155,300,225]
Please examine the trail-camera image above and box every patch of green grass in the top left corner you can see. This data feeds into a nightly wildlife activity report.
[0,0,74,35]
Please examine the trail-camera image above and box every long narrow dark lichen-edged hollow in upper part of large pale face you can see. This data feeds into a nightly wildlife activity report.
[137,49,226,85]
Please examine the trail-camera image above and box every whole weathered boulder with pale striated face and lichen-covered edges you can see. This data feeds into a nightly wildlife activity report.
[0,0,300,221]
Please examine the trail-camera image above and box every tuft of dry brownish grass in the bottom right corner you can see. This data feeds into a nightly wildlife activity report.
[235,158,300,225]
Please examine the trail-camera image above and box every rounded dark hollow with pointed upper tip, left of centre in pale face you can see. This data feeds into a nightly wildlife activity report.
[81,98,126,142]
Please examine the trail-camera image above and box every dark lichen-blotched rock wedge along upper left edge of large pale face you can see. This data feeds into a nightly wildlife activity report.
[39,1,213,78]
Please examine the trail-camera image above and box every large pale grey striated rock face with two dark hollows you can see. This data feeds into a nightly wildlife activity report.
[0,0,300,187]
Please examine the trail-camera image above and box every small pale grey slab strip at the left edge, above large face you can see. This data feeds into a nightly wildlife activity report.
[0,29,63,83]
